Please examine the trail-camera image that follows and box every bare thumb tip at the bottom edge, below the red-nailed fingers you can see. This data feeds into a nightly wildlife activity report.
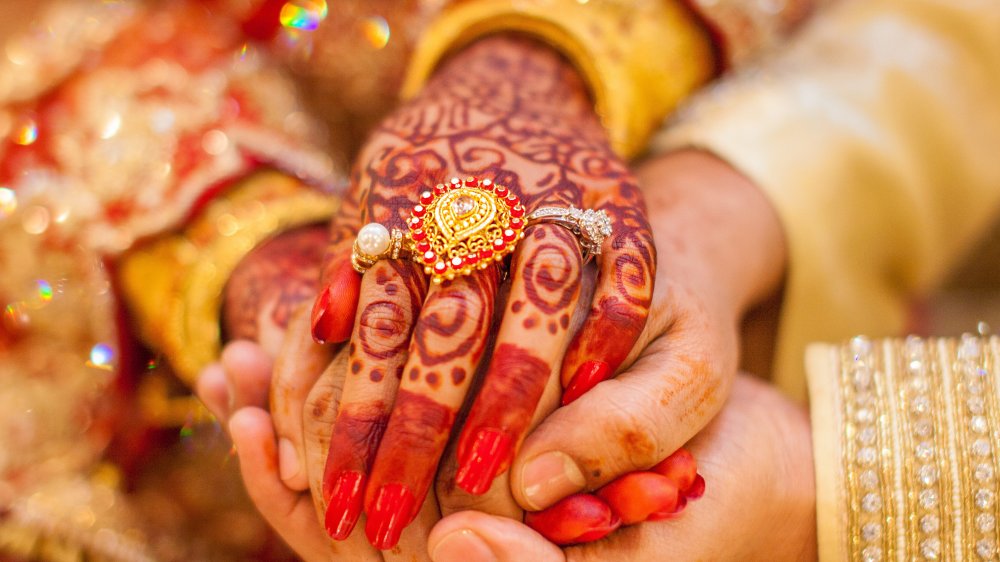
[427,511,566,562]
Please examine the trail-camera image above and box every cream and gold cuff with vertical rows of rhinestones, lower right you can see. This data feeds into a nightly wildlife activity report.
[807,335,1000,561]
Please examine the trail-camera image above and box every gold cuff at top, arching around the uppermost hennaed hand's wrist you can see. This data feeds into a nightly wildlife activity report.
[402,0,716,157]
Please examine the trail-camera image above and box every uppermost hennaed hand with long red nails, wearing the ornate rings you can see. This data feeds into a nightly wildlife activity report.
[313,32,656,549]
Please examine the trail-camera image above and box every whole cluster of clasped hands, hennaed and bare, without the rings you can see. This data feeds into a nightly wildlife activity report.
[199,37,815,560]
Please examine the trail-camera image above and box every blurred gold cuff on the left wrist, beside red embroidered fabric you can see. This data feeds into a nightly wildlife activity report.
[118,171,339,385]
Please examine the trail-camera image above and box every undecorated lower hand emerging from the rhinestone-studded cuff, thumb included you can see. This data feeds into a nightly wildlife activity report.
[428,376,817,562]
